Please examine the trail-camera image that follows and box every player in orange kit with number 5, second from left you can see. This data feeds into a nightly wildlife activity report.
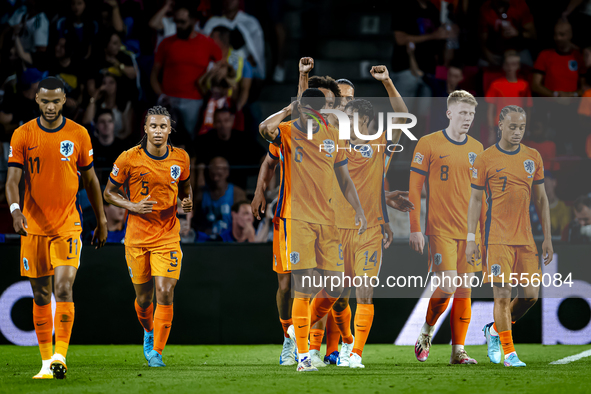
[104,106,193,367]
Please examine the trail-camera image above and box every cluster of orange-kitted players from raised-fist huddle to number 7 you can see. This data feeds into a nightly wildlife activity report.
[252,58,553,372]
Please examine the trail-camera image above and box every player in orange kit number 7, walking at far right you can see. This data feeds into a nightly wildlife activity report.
[466,105,554,367]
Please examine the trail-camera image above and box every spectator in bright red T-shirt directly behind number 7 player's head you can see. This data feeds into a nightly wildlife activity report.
[485,51,533,145]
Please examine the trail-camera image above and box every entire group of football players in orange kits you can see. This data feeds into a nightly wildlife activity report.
[6,54,553,379]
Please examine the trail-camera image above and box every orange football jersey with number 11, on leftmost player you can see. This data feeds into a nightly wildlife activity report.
[8,117,93,235]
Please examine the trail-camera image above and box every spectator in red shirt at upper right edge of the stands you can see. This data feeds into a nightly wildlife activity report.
[532,19,587,97]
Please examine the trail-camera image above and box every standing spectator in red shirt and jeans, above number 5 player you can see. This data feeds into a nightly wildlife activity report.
[150,2,222,139]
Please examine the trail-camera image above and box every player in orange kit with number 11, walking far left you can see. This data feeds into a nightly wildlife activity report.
[6,77,107,379]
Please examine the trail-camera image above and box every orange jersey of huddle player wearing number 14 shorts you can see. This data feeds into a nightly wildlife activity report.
[334,135,392,229]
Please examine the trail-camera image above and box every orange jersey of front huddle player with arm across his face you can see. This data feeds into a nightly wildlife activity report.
[277,120,347,225]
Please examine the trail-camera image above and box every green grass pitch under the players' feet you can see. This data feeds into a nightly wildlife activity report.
[0,344,591,394]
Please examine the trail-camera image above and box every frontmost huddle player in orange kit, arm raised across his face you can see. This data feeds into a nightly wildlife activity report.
[259,89,366,372]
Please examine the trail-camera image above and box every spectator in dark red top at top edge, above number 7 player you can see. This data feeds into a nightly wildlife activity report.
[480,0,536,66]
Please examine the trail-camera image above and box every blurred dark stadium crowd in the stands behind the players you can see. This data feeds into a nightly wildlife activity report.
[0,0,591,243]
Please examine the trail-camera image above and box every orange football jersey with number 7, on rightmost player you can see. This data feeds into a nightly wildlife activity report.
[472,143,544,245]
